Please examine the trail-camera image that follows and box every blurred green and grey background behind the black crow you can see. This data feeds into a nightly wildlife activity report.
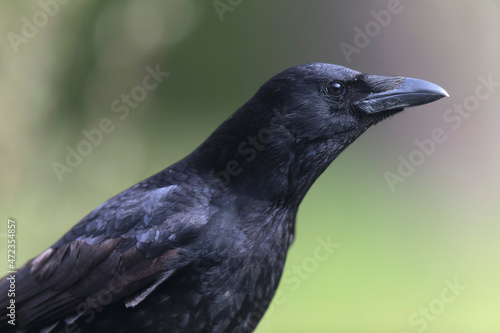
[0,0,500,333]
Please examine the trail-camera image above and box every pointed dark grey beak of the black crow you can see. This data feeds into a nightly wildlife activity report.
[356,77,449,114]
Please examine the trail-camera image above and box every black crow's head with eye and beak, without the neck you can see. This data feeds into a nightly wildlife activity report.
[255,63,448,140]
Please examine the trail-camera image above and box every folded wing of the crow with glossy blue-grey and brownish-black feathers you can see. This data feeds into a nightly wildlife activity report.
[0,186,207,331]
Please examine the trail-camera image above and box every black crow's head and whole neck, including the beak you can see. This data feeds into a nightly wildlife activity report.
[192,63,448,202]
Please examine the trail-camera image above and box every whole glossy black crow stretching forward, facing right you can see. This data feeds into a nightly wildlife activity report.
[0,63,448,333]
